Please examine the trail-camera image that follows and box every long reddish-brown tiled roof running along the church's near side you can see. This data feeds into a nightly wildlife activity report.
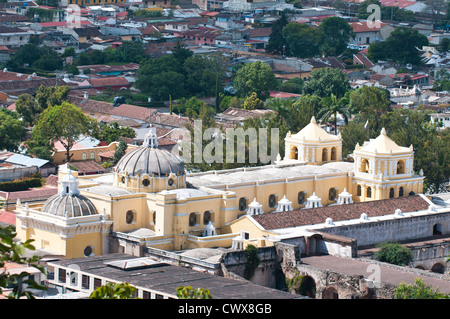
[252,195,430,230]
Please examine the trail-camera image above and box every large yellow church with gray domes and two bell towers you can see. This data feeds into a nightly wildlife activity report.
[15,118,424,258]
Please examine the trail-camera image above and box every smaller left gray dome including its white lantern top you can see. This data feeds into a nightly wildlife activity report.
[41,170,97,218]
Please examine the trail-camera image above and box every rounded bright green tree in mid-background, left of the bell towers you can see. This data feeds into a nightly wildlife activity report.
[234,61,278,100]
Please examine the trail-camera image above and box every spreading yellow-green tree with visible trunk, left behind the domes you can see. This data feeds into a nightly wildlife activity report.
[32,102,98,162]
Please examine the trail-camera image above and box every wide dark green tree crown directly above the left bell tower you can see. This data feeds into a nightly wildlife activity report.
[303,67,351,98]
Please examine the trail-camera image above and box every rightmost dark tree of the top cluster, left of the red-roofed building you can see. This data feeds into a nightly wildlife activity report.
[319,17,355,56]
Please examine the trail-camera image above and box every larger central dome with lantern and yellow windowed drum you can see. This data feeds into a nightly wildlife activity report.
[114,126,185,192]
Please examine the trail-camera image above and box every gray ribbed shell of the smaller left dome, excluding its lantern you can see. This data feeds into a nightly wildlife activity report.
[42,194,97,218]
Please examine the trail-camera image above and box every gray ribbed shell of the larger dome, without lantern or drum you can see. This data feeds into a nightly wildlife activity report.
[116,146,184,177]
